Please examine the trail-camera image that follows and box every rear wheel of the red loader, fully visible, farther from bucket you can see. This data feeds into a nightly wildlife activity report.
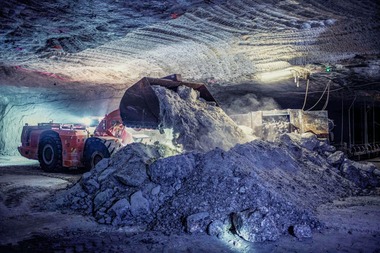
[38,135,63,172]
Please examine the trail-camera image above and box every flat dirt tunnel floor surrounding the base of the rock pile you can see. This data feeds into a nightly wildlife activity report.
[0,156,380,252]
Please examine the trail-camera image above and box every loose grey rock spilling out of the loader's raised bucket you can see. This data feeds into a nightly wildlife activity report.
[153,86,251,152]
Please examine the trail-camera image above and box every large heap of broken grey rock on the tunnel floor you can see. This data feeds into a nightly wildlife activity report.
[54,134,379,242]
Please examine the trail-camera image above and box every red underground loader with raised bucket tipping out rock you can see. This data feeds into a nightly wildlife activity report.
[18,75,216,172]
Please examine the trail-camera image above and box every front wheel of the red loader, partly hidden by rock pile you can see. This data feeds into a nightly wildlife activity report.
[83,137,110,170]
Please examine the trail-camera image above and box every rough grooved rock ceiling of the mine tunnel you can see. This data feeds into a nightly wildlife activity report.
[0,0,380,107]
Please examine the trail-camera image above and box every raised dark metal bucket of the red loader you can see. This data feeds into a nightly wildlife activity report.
[119,75,217,129]
